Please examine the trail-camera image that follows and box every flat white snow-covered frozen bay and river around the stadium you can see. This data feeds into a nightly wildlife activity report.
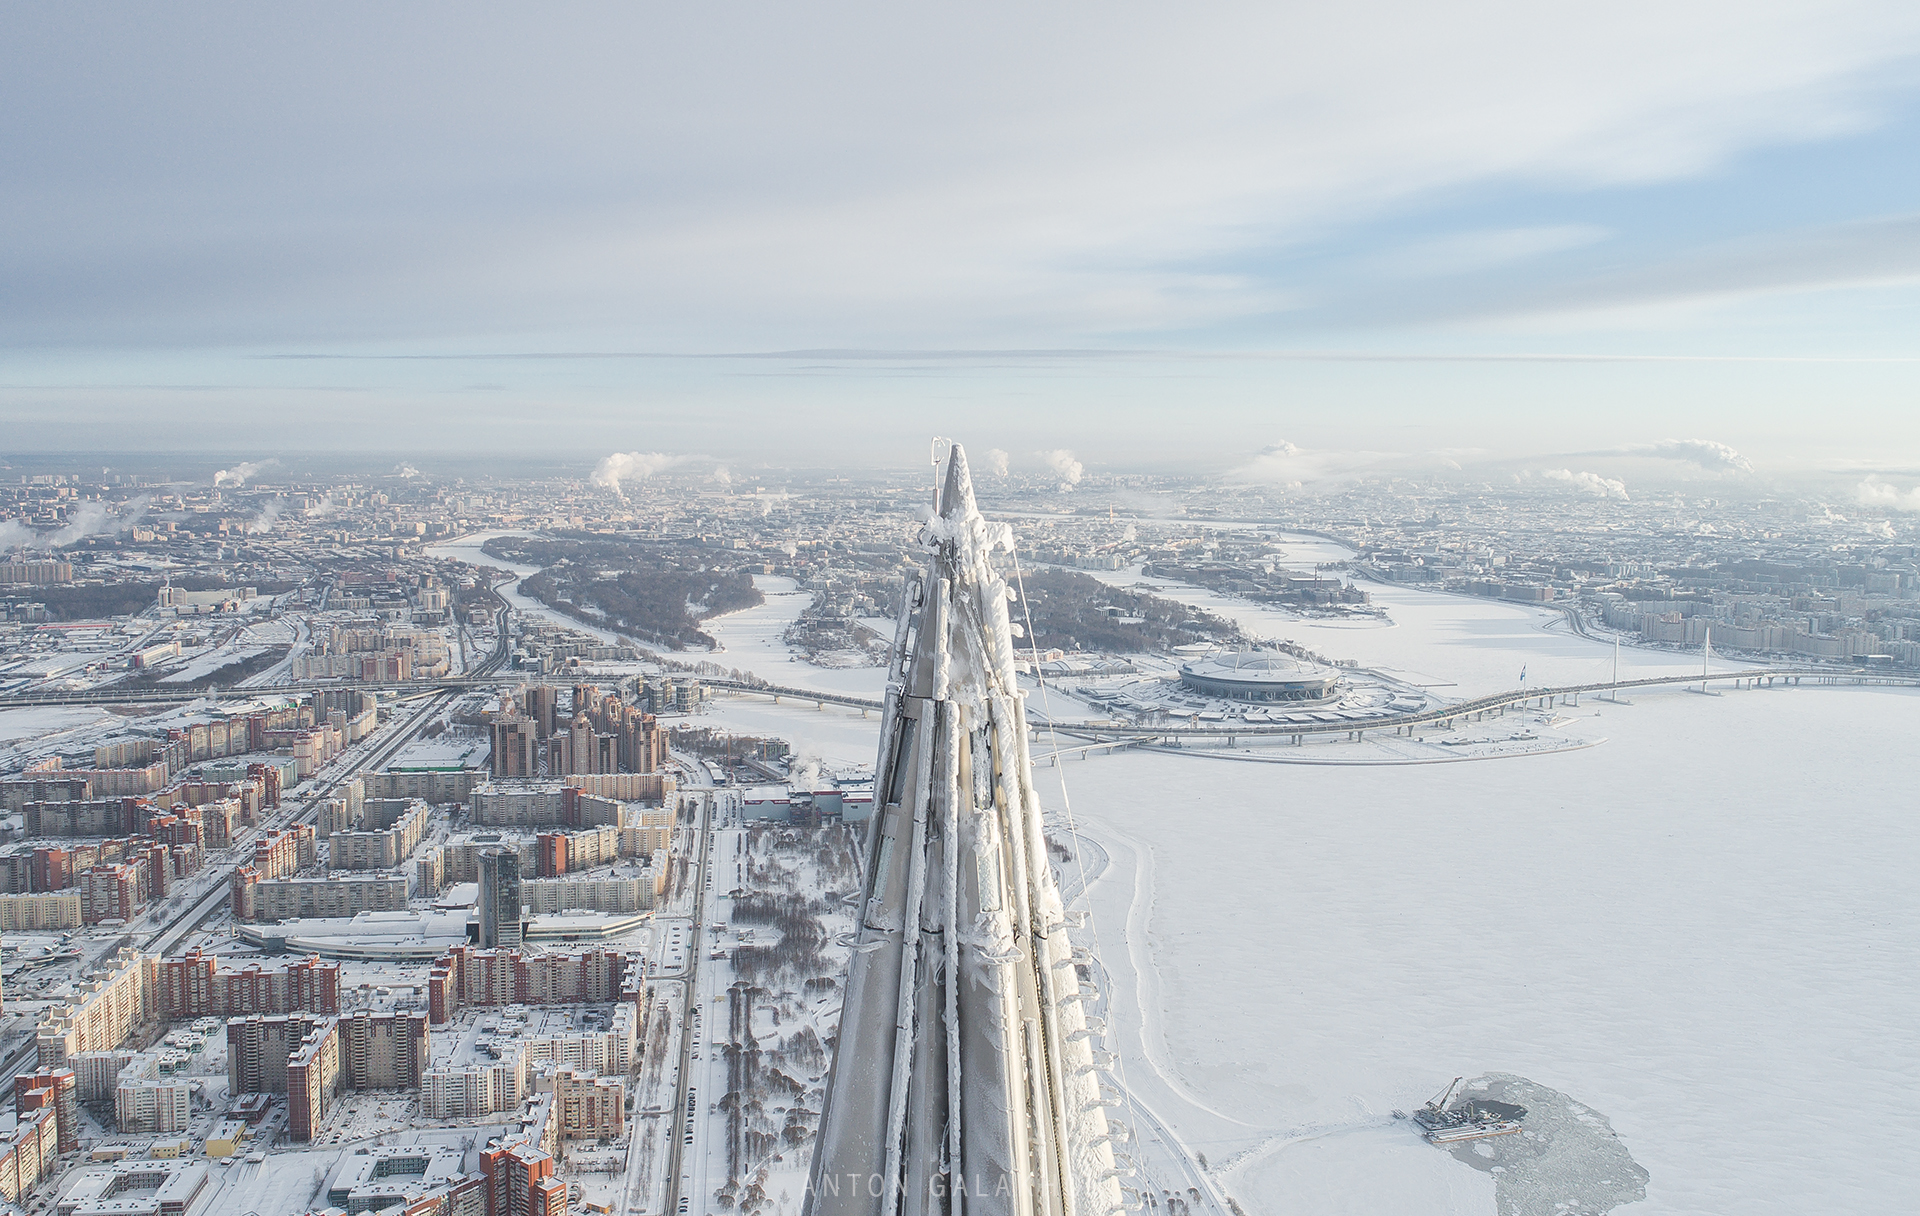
[683,549,1920,1216]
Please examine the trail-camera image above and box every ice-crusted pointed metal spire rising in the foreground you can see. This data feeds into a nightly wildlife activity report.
[806,444,1125,1216]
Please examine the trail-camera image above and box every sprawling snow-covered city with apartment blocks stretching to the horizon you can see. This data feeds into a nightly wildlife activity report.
[0,453,1920,1216]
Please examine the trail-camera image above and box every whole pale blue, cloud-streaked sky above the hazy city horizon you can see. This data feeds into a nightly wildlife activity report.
[0,0,1920,494]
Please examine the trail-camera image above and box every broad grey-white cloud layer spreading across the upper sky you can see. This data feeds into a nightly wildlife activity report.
[0,0,1920,348]
